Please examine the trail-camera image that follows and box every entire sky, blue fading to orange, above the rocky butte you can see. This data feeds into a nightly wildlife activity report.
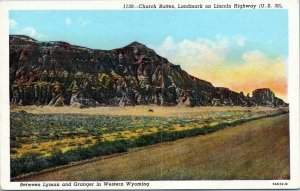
[9,9,288,101]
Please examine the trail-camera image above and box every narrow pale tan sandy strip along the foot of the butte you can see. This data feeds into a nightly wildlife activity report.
[11,105,278,118]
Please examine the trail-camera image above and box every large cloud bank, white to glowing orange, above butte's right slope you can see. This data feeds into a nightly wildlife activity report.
[151,35,287,98]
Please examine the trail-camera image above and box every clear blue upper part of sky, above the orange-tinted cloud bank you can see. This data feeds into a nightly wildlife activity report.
[10,10,288,55]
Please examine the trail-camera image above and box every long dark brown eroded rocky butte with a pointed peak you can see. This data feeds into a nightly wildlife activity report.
[9,35,287,108]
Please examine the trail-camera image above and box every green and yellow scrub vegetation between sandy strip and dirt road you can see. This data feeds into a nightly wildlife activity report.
[11,111,285,177]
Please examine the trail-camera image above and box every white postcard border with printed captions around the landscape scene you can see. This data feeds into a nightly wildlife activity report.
[0,0,300,190]
